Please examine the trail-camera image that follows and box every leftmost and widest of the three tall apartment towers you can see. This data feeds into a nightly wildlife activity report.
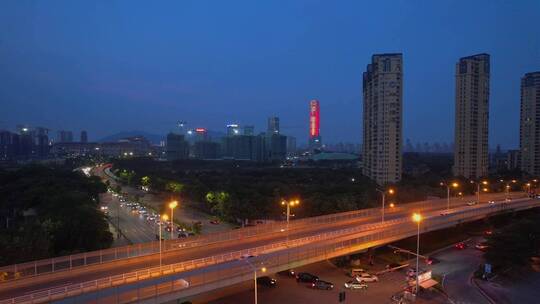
[362,53,403,185]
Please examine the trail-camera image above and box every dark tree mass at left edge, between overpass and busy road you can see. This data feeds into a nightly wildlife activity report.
[0,165,113,265]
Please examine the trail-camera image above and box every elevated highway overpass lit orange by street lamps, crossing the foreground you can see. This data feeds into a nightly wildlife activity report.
[0,193,538,304]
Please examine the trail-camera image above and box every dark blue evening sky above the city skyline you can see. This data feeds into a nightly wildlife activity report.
[0,0,540,147]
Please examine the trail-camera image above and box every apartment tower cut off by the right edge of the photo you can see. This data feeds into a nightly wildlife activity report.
[519,72,540,176]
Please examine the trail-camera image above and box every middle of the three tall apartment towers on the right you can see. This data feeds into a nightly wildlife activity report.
[454,54,490,178]
